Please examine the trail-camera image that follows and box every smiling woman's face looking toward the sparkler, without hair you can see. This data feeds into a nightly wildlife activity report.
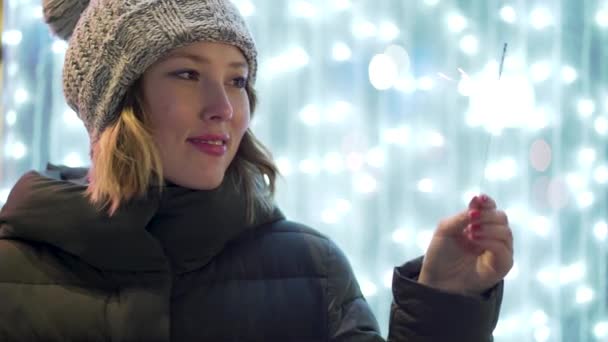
[142,42,250,190]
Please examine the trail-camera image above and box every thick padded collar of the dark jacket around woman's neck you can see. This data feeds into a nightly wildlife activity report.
[0,169,284,273]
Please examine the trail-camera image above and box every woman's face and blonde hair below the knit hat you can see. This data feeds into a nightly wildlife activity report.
[88,42,278,221]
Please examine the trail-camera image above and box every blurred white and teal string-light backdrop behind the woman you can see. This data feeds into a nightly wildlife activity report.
[0,0,608,342]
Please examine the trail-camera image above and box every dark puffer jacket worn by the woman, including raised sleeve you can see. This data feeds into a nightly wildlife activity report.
[0,165,502,342]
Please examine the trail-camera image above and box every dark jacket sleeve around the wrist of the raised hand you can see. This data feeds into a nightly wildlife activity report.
[388,257,503,342]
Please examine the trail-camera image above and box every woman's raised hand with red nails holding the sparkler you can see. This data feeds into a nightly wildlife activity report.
[418,195,513,295]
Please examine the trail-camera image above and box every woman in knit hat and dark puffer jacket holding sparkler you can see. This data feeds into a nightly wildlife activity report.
[0,0,513,342]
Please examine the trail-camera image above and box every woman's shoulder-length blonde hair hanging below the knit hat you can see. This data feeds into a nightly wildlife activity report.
[86,83,279,223]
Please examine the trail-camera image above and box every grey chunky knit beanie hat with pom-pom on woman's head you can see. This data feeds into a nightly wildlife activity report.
[43,0,257,139]
